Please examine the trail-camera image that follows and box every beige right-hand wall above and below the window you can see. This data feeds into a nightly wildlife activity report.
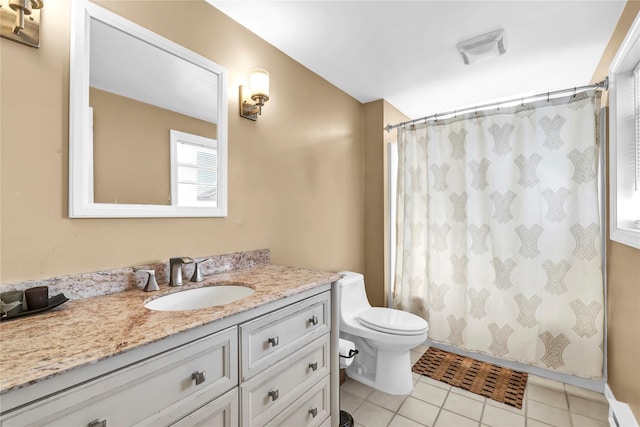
[593,1,640,420]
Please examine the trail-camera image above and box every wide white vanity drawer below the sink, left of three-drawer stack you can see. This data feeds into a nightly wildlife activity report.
[2,327,238,427]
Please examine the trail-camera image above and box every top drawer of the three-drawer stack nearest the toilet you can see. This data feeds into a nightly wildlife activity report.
[240,292,331,381]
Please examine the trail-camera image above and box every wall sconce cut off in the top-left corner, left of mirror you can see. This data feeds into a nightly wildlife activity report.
[0,0,44,47]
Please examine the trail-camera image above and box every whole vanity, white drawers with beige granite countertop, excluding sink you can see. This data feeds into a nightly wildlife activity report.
[0,254,339,427]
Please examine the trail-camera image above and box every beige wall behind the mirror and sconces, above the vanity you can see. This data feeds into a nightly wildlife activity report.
[0,0,364,284]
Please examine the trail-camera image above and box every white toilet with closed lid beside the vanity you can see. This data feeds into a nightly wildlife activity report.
[338,271,429,394]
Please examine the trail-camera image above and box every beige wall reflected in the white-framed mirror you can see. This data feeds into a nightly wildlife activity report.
[89,87,216,205]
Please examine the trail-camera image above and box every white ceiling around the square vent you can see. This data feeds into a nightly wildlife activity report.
[207,0,625,118]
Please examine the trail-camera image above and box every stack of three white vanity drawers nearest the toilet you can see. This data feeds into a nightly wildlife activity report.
[240,292,331,427]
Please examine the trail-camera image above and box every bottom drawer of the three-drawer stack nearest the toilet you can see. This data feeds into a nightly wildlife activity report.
[267,376,331,427]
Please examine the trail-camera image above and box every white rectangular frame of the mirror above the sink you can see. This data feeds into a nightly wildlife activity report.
[69,0,228,218]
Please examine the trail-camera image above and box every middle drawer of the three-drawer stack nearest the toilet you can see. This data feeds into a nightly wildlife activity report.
[240,334,329,426]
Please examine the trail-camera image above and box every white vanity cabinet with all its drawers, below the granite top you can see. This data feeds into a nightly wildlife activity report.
[0,288,337,427]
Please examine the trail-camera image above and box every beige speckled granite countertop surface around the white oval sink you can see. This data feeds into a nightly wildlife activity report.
[0,264,340,394]
